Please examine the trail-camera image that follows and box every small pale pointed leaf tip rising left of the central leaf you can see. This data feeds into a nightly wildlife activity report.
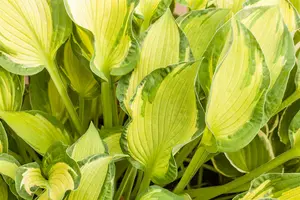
[67,123,106,162]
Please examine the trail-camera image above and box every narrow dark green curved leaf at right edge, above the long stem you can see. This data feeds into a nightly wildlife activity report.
[278,100,300,145]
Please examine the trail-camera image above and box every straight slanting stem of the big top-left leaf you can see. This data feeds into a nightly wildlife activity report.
[46,61,83,133]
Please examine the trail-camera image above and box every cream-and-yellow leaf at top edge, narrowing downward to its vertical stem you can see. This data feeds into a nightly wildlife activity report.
[64,0,138,81]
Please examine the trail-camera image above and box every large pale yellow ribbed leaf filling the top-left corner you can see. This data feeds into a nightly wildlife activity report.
[0,0,72,74]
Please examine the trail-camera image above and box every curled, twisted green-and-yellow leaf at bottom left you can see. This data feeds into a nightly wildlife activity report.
[16,143,81,200]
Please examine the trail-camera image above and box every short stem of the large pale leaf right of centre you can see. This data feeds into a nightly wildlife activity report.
[174,146,210,193]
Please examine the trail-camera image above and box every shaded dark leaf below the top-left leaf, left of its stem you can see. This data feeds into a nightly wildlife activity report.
[29,70,66,120]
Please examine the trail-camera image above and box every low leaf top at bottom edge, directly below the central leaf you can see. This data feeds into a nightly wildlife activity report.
[137,185,191,200]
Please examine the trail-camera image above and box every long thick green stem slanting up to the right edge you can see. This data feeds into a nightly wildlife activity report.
[187,148,300,200]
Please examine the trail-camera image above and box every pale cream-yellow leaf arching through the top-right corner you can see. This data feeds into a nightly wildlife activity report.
[244,0,300,32]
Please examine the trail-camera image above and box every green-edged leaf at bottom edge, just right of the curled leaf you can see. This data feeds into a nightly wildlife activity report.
[68,155,115,200]
